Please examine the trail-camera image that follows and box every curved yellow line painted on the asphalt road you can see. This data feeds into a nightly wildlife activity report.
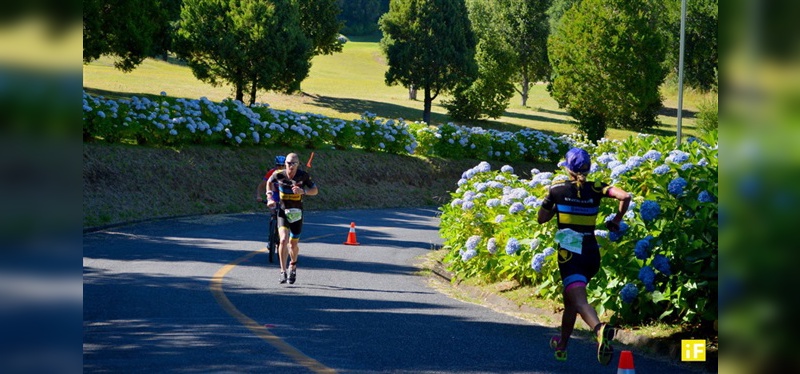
[209,248,336,373]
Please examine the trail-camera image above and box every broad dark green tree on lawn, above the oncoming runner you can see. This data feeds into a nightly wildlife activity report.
[175,0,312,104]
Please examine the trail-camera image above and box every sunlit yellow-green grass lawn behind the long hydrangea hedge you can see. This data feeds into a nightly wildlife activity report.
[83,37,705,139]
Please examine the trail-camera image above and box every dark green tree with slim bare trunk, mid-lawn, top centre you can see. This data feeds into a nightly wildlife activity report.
[379,0,477,123]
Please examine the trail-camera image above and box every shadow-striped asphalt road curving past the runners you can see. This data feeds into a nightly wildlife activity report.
[83,209,685,373]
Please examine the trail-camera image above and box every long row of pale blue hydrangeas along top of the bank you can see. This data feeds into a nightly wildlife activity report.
[83,92,566,162]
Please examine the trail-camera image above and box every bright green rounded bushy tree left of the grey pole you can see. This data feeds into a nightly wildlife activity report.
[548,0,665,141]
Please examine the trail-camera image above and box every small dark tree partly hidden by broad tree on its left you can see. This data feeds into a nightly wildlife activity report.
[297,0,342,55]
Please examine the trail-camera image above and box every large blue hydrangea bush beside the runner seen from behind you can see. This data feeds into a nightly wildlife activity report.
[440,132,718,324]
